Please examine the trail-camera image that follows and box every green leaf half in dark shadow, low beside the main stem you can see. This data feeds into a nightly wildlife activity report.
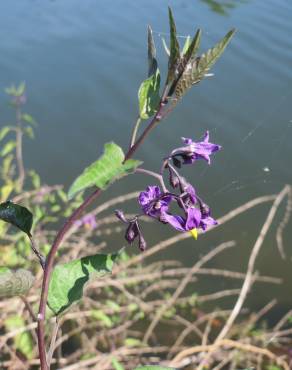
[48,254,118,315]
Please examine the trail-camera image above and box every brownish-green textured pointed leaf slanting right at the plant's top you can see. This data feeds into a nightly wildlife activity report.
[175,29,235,99]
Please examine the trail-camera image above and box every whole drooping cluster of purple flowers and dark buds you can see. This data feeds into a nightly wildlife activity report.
[116,131,221,250]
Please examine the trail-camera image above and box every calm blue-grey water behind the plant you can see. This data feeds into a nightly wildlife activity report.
[0,0,292,309]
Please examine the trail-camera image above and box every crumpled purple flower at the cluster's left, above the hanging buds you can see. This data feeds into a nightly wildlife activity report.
[138,185,172,218]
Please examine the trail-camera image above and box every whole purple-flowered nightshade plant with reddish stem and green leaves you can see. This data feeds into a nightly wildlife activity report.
[0,9,235,370]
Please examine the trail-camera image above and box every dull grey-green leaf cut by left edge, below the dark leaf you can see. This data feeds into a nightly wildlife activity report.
[0,267,34,298]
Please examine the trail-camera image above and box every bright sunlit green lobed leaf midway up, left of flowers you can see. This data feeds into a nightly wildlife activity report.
[68,142,142,199]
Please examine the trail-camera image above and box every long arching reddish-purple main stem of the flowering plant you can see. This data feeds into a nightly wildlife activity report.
[37,86,171,370]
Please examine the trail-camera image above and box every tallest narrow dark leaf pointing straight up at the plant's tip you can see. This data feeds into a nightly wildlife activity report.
[167,7,180,82]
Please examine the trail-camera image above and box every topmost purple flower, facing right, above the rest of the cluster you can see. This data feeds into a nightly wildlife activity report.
[171,131,221,164]
